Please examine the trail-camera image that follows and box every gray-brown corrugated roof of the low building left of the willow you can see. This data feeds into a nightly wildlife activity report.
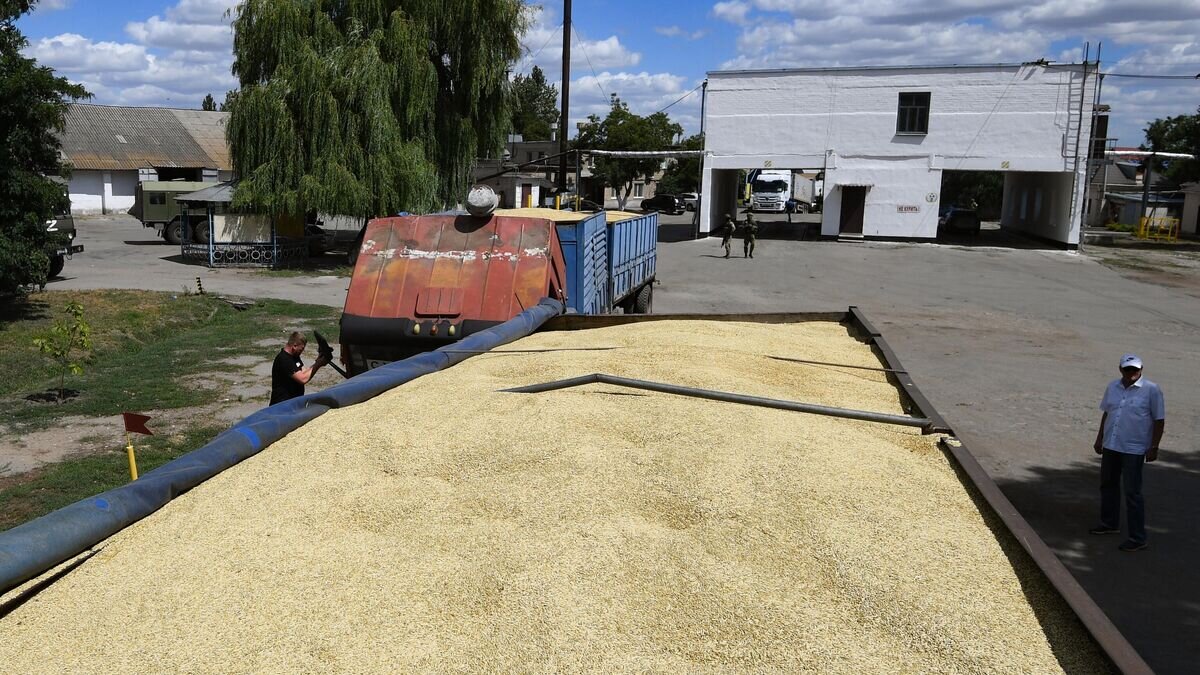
[61,103,233,171]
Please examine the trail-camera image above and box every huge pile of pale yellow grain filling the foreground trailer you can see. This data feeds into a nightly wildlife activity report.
[0,322,1103,673]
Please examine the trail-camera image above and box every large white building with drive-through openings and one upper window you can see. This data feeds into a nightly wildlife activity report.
[700,64,1096,247]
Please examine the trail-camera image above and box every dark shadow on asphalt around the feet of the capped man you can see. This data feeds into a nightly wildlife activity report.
[1000,449,1200,674]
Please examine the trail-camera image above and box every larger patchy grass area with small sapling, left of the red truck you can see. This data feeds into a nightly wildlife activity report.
[0,291,338,432]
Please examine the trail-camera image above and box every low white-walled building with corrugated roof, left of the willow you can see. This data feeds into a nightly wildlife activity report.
[60,103,233,214]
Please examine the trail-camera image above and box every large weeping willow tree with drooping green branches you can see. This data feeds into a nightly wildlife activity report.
[226,0,528,215]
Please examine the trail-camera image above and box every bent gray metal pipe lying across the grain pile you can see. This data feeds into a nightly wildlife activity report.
[502,372,932,434]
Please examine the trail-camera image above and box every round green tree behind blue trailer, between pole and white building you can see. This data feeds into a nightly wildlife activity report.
[576,94,683,209]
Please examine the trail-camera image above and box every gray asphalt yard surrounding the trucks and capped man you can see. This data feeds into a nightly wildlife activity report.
[52,210,1200,673]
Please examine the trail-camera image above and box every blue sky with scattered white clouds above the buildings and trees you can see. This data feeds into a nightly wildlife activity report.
[18,0,1200,145]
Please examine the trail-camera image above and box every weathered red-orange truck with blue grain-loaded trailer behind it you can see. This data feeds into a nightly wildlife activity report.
[341,209,658,375]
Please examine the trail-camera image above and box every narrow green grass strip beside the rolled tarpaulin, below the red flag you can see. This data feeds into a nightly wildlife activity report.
[0,426,224,531]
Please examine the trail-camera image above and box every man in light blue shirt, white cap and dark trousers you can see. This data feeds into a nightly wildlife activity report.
[1090,354,1166,551]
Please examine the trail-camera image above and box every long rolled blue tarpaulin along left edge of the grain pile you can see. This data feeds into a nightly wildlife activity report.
[0,298,563,593]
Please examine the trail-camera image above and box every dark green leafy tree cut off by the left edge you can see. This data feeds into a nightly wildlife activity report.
[0,0,89,294]
